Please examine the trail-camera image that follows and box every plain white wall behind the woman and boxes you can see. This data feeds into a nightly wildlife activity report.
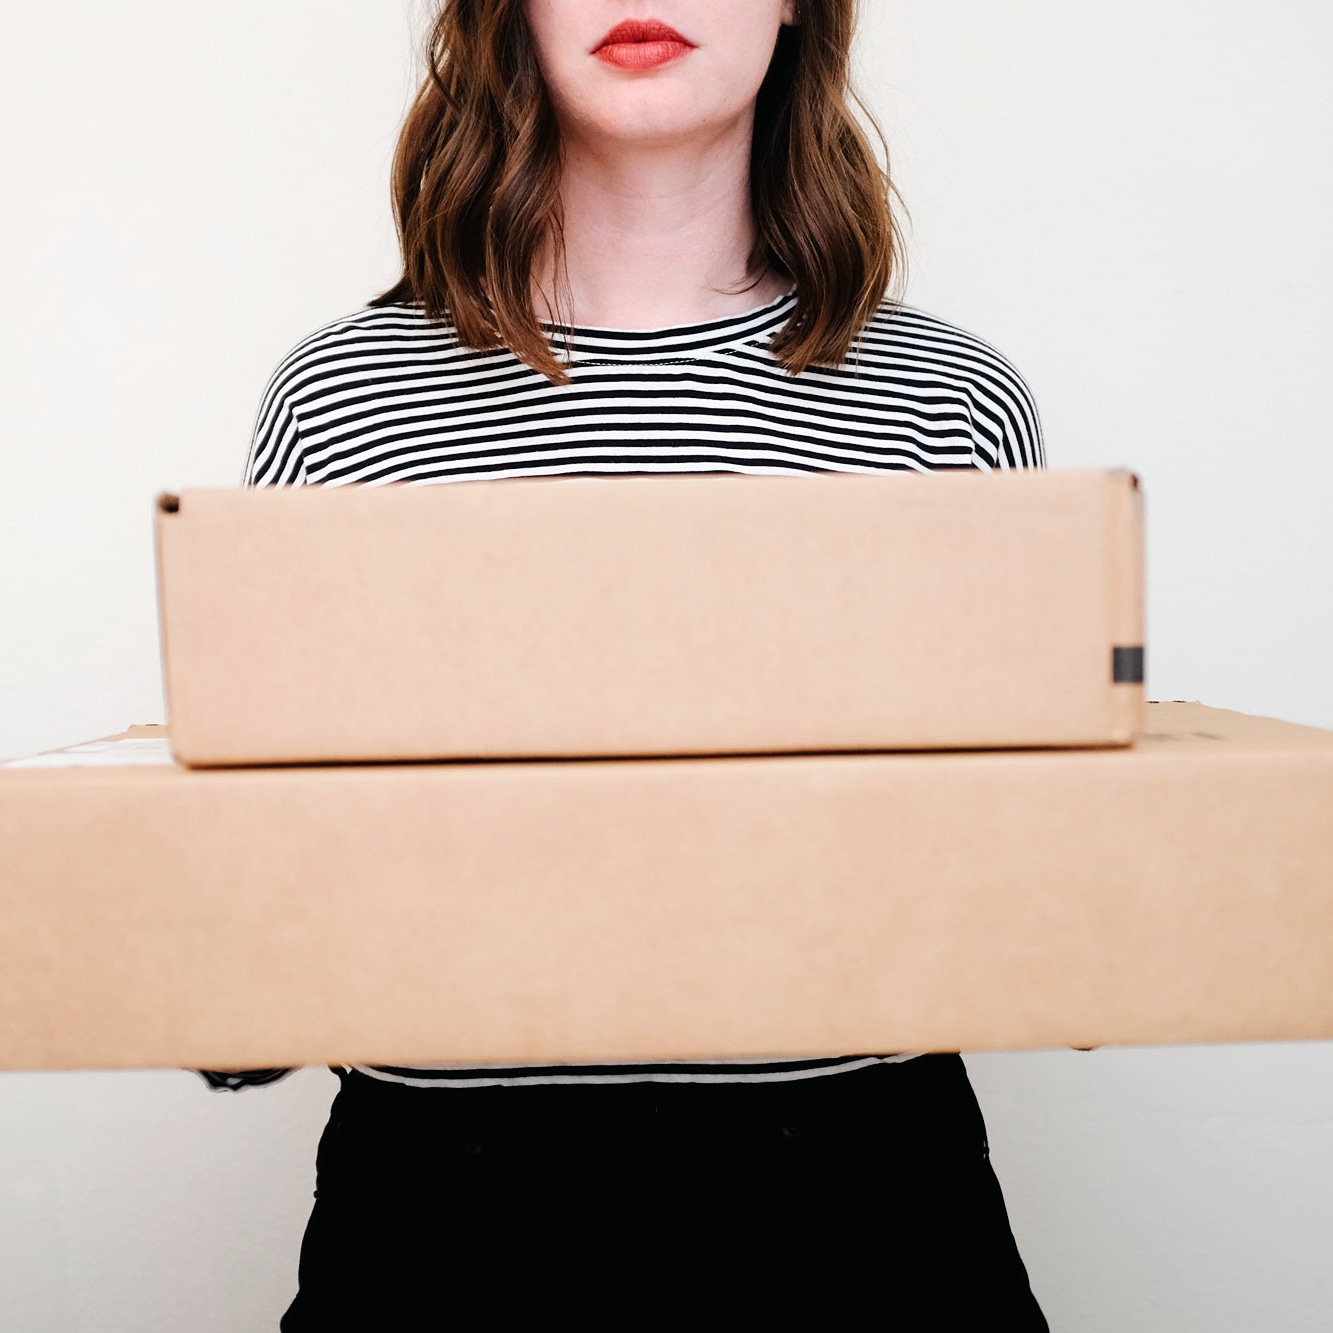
[0,0,1333,1333]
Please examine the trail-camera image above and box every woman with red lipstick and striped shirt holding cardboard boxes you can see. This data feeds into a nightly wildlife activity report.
[229,0,1046,1330]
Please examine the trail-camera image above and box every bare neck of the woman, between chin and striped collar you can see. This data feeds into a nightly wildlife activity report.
[537,124,790,329]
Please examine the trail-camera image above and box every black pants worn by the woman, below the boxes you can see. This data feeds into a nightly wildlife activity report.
[281,1056,1046,1333]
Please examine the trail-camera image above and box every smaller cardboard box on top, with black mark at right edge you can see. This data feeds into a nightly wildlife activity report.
[157,472,1144,765]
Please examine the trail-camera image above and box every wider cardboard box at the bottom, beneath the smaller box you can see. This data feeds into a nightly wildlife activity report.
[0,705,1333,1069]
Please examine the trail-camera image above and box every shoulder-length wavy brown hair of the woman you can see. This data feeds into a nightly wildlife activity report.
[372,0,902,384]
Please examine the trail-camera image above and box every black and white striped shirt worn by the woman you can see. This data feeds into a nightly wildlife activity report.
[221,286,1045,1086]
